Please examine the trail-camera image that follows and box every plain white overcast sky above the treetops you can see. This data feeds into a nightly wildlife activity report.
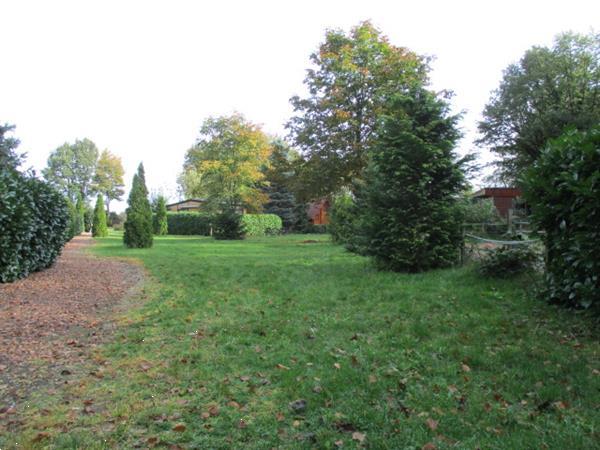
[0,0,600,210]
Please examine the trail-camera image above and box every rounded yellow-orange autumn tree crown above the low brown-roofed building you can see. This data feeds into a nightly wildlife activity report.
[179,114,271,211]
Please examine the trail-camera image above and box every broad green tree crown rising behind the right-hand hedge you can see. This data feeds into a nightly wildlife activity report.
[478,33,600,183]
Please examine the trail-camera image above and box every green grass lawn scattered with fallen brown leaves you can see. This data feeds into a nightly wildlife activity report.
[0,234,600,449]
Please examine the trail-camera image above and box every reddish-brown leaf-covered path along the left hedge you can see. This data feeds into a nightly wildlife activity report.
[0,235,143,418]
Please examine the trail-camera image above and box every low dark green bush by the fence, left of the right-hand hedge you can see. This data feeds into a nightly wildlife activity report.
[479,245,540,278]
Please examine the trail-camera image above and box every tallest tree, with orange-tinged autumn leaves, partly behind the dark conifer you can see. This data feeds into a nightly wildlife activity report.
[287,22,428,199]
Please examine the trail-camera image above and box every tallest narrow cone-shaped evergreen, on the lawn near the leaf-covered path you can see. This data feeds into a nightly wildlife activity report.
[123,163,153,248]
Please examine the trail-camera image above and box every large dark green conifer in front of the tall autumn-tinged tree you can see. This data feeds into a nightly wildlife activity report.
[355,88,465,272]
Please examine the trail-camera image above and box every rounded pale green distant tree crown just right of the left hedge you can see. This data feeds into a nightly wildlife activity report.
[42,138,98,203]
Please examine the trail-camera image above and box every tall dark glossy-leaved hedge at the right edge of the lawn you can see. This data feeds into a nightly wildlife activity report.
[523,127,600,308]
